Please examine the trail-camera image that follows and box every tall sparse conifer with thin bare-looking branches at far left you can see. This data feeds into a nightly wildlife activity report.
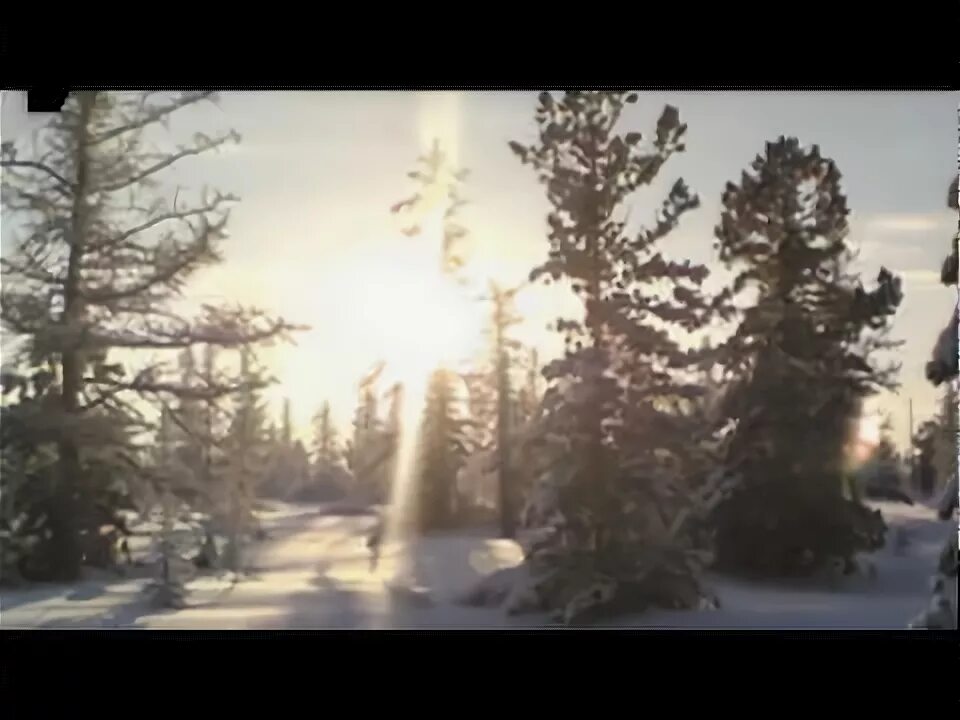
[0,92,289,580]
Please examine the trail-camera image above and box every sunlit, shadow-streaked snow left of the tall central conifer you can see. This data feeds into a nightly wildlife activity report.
[0,509,520,629]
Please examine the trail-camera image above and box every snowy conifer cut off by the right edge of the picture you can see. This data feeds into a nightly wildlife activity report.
[910,177,960,630]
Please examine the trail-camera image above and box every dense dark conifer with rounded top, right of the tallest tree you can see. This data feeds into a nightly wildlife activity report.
[713,137,902,575]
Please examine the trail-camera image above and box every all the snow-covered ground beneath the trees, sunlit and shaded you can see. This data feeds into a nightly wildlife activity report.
[0,503,956,629]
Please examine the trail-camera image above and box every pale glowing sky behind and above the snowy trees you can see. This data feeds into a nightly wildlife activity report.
[4,92,957,443]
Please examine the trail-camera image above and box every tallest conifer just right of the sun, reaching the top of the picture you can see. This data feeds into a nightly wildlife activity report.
[510,92,723,623]
